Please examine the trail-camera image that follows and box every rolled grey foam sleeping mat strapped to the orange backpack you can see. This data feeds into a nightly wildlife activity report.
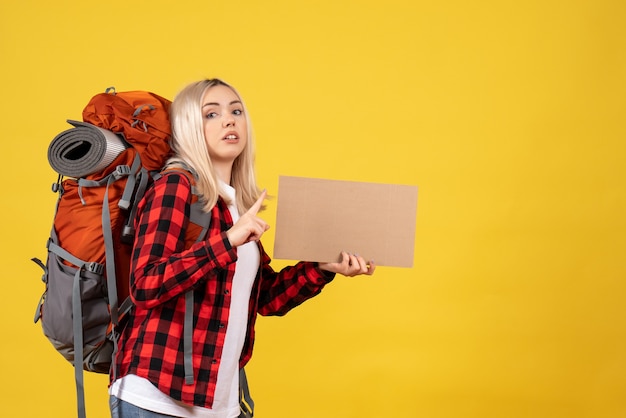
[48,120,128,178]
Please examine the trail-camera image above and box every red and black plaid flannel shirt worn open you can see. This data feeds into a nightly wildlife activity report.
[115,173,334,408]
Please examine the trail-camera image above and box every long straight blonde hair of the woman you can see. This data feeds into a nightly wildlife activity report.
[166,78,260,214]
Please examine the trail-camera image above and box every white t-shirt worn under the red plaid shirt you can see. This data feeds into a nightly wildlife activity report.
[109,183,260,418]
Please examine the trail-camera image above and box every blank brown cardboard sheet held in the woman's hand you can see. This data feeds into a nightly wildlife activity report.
[274,176,417,267]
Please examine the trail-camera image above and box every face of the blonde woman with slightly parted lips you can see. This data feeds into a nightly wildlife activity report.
[202,85,248,164]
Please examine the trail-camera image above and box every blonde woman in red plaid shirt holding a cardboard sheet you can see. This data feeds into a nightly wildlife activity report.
[110,79,375,418]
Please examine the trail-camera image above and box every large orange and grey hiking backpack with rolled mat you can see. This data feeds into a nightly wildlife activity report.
[33,88,171,417]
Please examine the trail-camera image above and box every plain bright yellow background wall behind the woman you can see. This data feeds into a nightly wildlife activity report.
[0,0,626,418]
